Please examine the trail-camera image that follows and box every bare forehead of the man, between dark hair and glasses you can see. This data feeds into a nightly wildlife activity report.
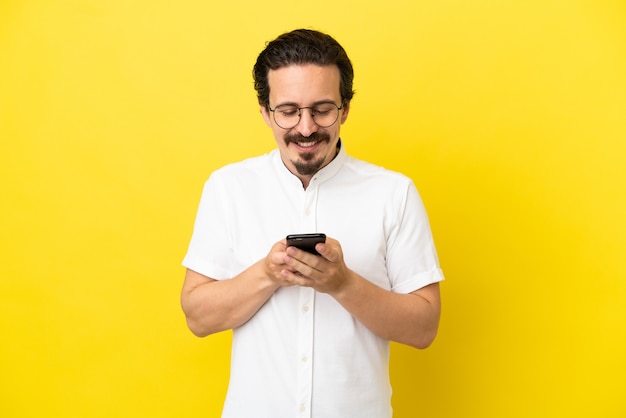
[267,64,341,106]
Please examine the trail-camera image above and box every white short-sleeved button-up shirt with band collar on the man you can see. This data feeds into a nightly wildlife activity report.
[183,142,443,418]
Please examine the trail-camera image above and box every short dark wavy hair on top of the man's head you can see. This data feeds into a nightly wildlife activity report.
[252,29,354,108]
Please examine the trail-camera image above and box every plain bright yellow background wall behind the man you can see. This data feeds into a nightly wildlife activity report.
[0,0,626,418]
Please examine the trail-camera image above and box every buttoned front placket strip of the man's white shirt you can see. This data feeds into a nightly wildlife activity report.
[297,178,323,418]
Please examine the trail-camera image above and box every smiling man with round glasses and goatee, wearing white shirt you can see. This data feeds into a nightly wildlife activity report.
[181,30,443,418]
